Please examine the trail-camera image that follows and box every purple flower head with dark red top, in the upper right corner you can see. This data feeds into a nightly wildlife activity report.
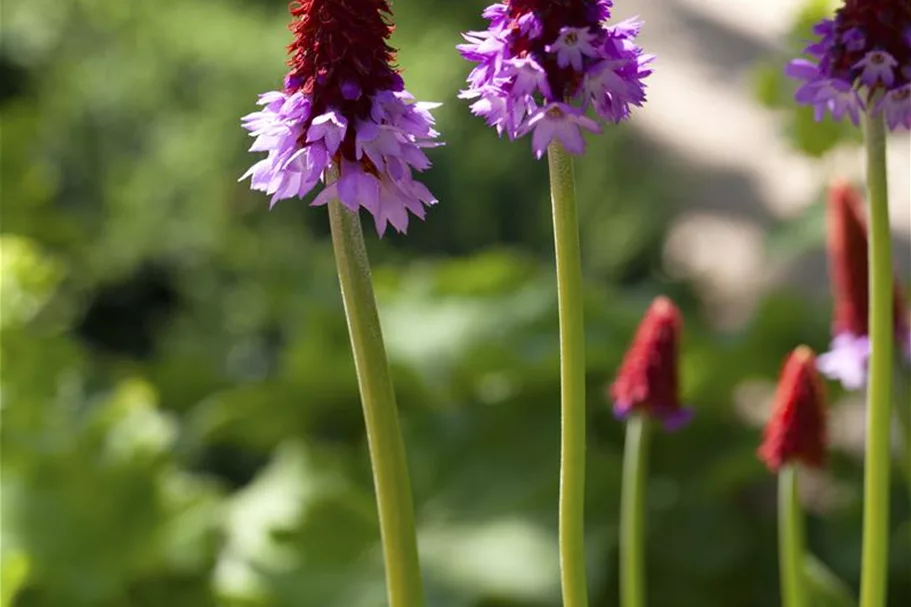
[787,0,911,130]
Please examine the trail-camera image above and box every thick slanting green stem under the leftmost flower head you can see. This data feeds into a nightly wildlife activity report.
[329,200,424,607]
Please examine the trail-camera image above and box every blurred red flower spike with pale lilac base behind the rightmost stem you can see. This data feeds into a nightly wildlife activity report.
[819,181,911,390]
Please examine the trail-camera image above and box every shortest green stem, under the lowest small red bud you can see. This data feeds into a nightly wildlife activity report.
[778,464,807,607]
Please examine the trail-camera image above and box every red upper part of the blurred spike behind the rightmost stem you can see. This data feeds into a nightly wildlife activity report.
[828,180,908,340]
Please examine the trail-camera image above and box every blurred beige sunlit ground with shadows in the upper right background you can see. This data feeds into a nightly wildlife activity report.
[615,0,911,325]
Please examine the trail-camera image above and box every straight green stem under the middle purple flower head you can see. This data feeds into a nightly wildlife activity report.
[547,142,588,607]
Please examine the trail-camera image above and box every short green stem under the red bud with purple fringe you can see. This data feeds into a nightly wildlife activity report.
[620,415,651,607]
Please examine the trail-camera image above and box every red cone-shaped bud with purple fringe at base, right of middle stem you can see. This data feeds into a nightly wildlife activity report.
[610,297,692,430]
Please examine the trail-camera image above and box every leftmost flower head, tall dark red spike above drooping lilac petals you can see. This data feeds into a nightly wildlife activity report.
[241,0,438,236]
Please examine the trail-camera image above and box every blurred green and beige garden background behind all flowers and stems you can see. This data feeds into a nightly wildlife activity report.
[0,0,911,607]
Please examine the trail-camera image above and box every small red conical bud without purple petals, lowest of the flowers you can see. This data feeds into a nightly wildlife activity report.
[759,346,826,472]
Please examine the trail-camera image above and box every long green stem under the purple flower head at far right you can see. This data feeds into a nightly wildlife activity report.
[860,110,895,607]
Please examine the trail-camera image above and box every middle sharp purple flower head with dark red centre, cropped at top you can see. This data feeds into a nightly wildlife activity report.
[459,0,653,158]
